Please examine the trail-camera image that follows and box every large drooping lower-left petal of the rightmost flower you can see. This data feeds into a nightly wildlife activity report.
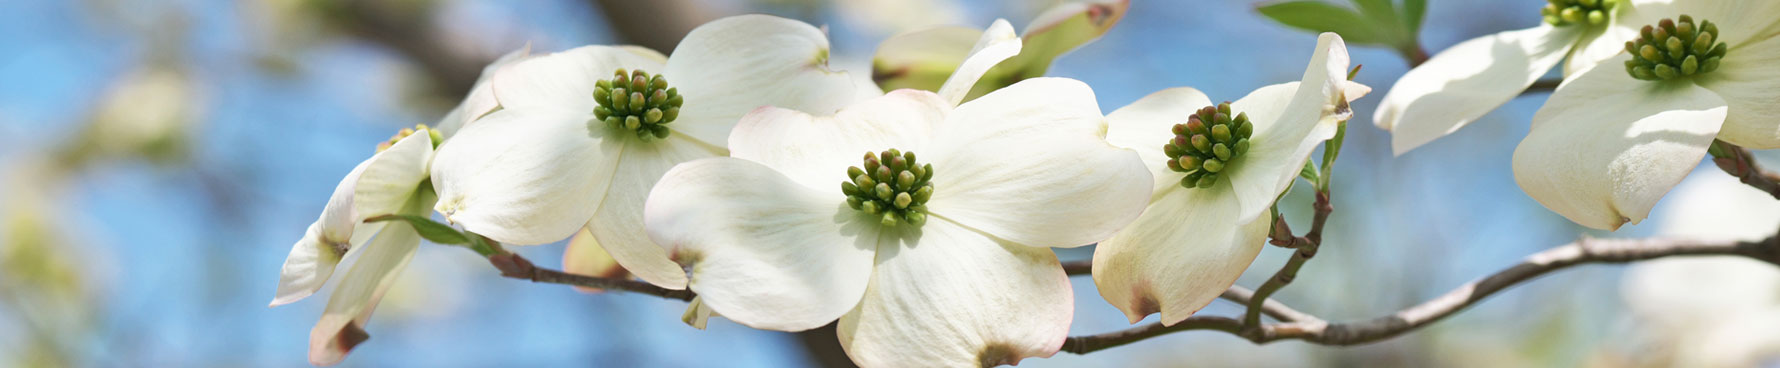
[1515,55,1727,229]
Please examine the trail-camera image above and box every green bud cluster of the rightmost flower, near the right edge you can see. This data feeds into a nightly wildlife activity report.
[1625,16,1730,80]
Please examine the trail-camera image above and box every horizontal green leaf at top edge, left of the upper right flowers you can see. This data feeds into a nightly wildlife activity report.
[1255,0,1396,46]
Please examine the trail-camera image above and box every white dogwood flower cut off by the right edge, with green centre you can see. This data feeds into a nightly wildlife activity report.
[1515,0,1780,229]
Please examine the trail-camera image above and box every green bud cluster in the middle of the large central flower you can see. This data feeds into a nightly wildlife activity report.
[840,148,933,226]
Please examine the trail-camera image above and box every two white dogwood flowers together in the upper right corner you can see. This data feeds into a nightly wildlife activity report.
[1374,0,1780,229]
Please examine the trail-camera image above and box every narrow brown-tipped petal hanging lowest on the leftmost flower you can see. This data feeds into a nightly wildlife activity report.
[310,219,420,366]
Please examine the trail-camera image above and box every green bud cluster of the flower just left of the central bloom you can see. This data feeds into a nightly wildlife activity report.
[593,69,685,140]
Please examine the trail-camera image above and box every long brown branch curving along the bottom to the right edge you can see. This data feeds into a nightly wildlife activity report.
[1063,236,1780,354]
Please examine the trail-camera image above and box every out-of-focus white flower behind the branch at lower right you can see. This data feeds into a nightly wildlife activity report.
[1620,176,1780,366]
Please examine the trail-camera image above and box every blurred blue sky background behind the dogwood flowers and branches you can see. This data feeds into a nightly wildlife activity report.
[0,0,1780,366]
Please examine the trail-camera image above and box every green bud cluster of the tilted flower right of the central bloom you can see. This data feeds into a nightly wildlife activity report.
[1162,101,1255,188]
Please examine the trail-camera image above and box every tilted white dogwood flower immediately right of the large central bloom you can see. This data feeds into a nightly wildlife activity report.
[1093,34,1369,325]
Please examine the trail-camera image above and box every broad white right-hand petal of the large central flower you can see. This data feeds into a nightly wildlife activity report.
[917,78,1152,247]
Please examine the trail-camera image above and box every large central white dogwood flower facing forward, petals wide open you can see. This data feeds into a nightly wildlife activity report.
[644,23,1152,366]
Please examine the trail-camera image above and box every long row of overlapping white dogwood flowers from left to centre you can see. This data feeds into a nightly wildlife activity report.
[274,16,1367,366]
